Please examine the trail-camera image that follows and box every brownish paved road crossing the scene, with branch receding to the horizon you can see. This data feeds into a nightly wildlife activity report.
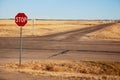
[0,23,120,62]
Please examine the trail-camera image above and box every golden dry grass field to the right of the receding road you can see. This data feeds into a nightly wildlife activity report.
[88,23,120,41]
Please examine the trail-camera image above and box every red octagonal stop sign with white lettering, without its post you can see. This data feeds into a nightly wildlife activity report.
[15,13,27,27]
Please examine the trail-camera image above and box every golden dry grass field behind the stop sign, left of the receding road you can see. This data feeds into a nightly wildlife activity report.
[0,20,102,37]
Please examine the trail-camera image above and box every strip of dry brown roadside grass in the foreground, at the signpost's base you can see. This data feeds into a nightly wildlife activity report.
[2,60,120,80]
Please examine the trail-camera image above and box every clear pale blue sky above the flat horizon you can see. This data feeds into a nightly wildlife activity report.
[0,0,120,20]
